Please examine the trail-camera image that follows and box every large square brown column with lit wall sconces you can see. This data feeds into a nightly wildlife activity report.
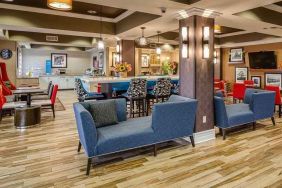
[179,15,214,132]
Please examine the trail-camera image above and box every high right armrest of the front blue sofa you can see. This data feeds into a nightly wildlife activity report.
[152,99,197,140]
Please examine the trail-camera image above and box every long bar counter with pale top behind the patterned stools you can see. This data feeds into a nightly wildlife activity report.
[81,76,179,97]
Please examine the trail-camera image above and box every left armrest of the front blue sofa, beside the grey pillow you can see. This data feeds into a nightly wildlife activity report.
[73,103,98,157]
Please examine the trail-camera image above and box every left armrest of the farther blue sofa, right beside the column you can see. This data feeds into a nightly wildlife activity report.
[214,96,228,128]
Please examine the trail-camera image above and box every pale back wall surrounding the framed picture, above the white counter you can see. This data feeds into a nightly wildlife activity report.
[23,49,91,76]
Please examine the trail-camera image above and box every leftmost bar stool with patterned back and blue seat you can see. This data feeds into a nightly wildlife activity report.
[75,78,106,102]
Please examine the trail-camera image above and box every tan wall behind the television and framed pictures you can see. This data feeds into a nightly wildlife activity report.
[222,43,282,86]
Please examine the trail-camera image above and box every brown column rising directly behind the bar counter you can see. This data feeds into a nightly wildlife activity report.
[121,40,135,76]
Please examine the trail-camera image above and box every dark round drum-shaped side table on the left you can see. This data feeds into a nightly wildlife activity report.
[14,105,41,129]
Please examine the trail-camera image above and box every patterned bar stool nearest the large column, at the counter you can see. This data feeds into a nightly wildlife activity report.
[147,78,172,115]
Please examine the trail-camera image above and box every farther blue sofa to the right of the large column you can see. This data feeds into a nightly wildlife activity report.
[214,89,275,139]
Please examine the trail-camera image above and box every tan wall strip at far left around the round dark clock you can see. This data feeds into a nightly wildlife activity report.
[0,40,17,84]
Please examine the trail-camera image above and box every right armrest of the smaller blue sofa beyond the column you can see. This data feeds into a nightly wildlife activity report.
[250,91,275,120]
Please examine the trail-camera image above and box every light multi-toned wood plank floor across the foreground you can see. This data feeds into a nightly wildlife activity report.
[0,91,282,188]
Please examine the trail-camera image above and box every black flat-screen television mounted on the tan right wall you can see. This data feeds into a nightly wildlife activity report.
[249,51,277,69]
